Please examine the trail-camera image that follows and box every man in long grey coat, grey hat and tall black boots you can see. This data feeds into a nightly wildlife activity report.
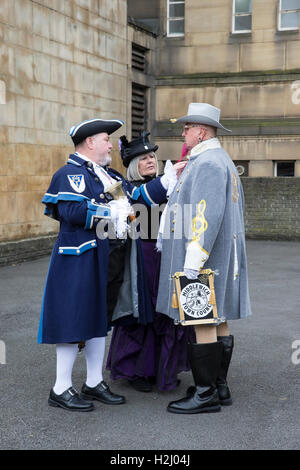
[156,103,251,414]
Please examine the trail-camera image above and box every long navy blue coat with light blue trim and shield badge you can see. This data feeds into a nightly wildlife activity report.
[38,154,166,344]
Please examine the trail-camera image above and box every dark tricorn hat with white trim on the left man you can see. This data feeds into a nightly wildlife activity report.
[69,119,124,145]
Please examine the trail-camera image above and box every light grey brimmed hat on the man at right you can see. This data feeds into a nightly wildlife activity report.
[176,103,232,132]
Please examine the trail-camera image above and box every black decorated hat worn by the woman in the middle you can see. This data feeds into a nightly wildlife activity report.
[119,131,158,168]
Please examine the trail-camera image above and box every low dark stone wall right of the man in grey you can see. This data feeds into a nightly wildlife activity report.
[241,177,300,240]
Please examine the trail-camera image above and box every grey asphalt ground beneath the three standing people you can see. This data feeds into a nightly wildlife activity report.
[0,241,300,450]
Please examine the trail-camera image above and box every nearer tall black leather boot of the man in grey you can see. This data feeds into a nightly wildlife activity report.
[167,342,223,414]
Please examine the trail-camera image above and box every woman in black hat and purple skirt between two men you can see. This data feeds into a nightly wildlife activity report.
[107,131,194,392]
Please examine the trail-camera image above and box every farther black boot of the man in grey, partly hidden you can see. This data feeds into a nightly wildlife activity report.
[217,335,234,406]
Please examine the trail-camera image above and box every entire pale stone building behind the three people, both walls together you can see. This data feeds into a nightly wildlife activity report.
[0,0,300,262]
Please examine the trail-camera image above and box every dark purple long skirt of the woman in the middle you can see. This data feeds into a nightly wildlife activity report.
[106,241,195,390]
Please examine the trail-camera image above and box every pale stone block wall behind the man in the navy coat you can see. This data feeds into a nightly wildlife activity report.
[0,0,128,242]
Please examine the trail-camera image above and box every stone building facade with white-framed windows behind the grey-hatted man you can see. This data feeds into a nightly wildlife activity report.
[129,0,300,177]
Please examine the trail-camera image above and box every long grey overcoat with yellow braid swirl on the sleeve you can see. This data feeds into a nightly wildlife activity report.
[156,138,251,321]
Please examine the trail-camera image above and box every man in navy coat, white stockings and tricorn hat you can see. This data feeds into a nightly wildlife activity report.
[38,119,169,411]
